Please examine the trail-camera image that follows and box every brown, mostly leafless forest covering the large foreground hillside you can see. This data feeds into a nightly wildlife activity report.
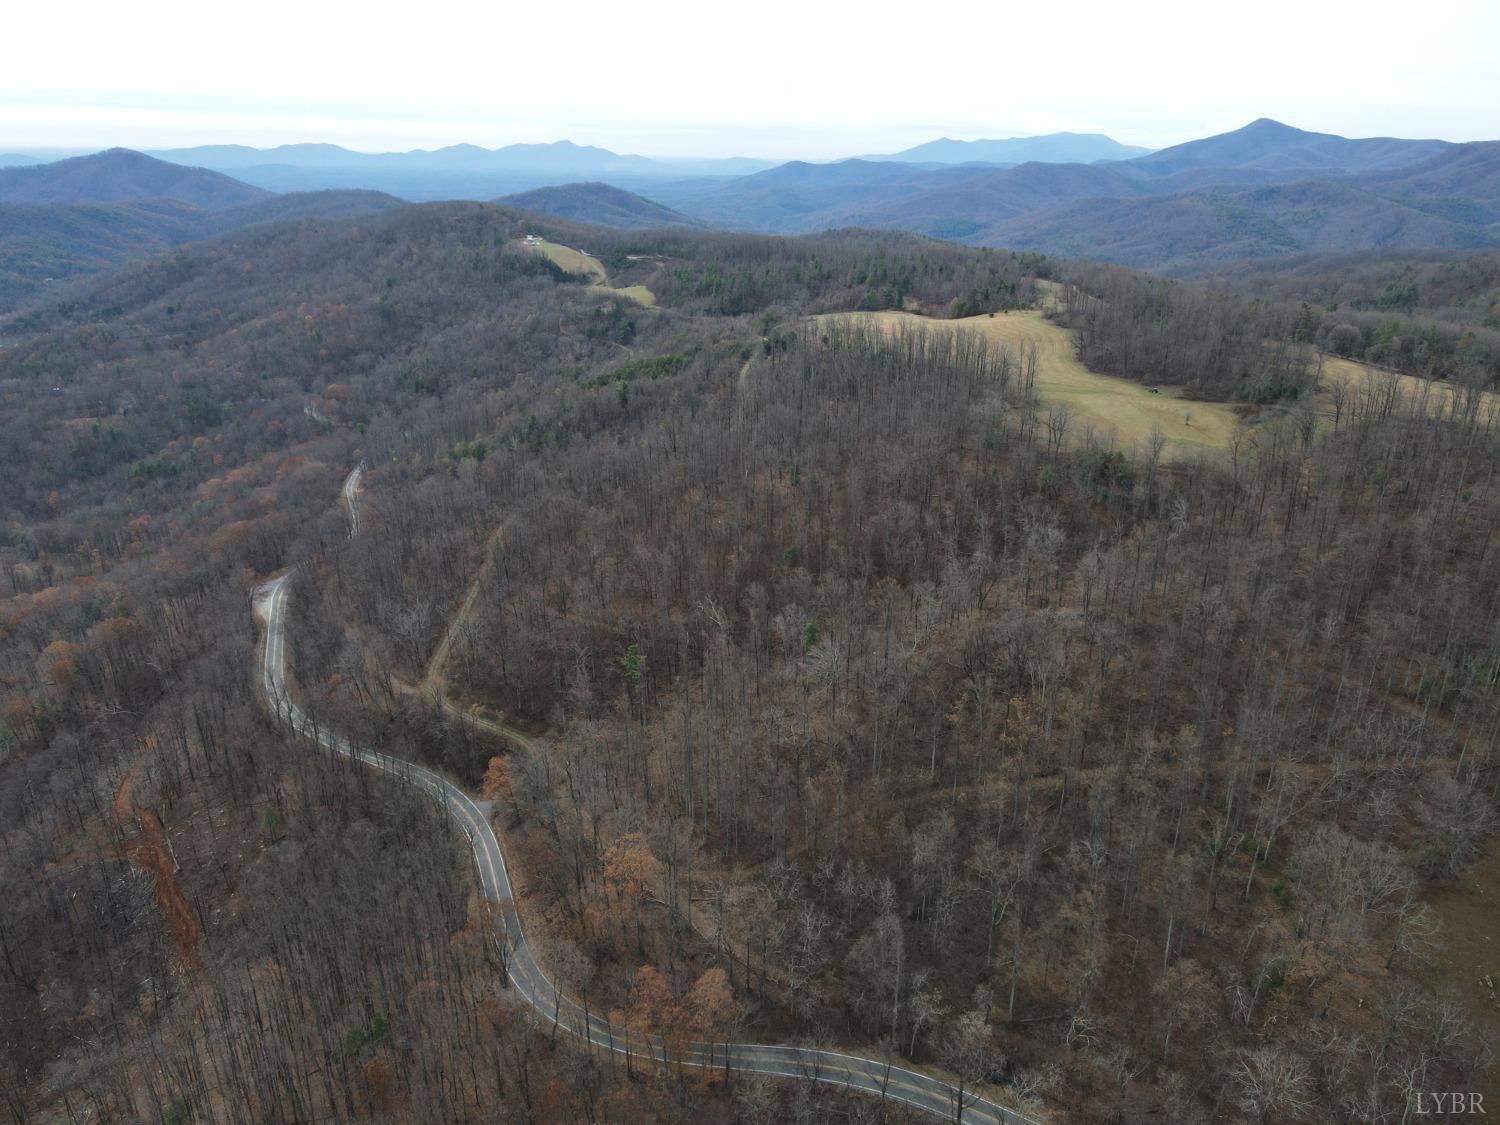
[0,204,1500,1122]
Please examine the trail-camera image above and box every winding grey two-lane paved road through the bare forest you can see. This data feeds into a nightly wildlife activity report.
[254,467,1040,1125]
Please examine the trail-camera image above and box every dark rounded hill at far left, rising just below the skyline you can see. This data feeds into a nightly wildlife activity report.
[0,149,269,212]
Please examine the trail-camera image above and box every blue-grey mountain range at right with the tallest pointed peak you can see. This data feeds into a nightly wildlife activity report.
[639,119,1500,273]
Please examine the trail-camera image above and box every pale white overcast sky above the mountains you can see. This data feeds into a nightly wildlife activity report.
[0,0,1500,158]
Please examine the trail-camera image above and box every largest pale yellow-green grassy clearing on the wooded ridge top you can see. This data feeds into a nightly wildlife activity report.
[833,312,1241,461]
